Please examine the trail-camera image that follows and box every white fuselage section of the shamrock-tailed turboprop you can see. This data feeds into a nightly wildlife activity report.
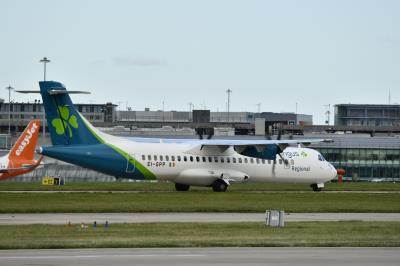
[108,134,336,186]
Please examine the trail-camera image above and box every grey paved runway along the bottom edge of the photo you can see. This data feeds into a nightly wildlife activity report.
[0,248,400,266]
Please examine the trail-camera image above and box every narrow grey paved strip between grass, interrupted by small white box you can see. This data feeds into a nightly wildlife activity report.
[0,212,400,225]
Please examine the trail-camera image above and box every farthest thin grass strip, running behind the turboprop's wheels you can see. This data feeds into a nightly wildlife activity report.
[0,180,400,192]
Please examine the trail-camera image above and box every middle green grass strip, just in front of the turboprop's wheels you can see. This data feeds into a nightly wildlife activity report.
[0,191,400,213]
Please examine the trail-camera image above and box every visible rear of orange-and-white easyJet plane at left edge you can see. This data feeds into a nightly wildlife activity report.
[0,120,43,180]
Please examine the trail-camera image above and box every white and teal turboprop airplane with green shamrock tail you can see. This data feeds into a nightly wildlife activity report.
[28,81,336,192]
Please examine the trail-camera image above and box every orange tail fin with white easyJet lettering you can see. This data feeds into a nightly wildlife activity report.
[8,120,40,162]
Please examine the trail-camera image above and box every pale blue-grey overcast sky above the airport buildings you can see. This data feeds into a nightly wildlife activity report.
[0,0,400,124]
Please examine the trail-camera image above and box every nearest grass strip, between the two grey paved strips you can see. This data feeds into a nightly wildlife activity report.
[0,221,400,249]
